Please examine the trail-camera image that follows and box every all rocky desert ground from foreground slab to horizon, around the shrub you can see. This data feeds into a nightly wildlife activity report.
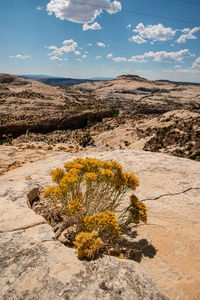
[0,74,200,300]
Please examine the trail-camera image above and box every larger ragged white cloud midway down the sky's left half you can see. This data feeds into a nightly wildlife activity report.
[47,39,80,56]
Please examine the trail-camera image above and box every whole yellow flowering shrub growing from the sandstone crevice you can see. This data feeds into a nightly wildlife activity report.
[45,158,147,258]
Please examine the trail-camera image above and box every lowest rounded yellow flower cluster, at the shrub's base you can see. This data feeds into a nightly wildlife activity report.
[74,231,103,259]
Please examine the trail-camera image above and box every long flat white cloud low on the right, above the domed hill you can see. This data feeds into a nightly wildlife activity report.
[128,49,194,63]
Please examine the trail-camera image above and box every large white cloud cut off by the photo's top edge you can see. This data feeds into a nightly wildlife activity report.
[47,0,122,24]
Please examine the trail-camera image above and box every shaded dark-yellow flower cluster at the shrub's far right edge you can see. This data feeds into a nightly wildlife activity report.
[130,194,147,224]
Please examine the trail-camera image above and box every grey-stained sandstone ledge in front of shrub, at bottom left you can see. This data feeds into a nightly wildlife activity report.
[0,225,168,300]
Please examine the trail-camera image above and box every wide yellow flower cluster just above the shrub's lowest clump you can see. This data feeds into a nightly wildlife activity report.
[83,210,121,237]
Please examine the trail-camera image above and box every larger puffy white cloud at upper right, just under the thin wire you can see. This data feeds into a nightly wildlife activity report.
[133,23,176,41]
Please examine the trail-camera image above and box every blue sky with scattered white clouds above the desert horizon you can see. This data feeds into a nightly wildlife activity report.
[0,0,200,82]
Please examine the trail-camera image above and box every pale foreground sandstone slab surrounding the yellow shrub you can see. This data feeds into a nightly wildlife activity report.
[0,150,200,300]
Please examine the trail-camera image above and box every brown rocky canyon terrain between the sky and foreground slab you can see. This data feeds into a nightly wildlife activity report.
[0,74,200,160]
